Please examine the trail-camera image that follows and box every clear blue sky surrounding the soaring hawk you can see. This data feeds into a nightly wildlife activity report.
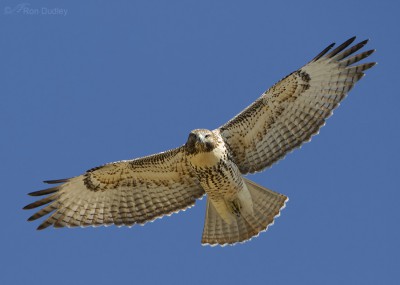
[0,0,400,285]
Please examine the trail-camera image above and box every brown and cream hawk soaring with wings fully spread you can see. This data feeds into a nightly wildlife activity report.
[24,37,375,246]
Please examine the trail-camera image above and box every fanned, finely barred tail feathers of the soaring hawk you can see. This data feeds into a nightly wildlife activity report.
[201,179,288,246]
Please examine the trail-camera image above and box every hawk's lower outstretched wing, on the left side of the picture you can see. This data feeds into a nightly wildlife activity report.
[24,147,204,229]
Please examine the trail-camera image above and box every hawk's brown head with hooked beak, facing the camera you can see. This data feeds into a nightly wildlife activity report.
[185,129,218,154]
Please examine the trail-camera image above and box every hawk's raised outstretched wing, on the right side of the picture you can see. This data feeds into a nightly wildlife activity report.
[219,37,375,174]
